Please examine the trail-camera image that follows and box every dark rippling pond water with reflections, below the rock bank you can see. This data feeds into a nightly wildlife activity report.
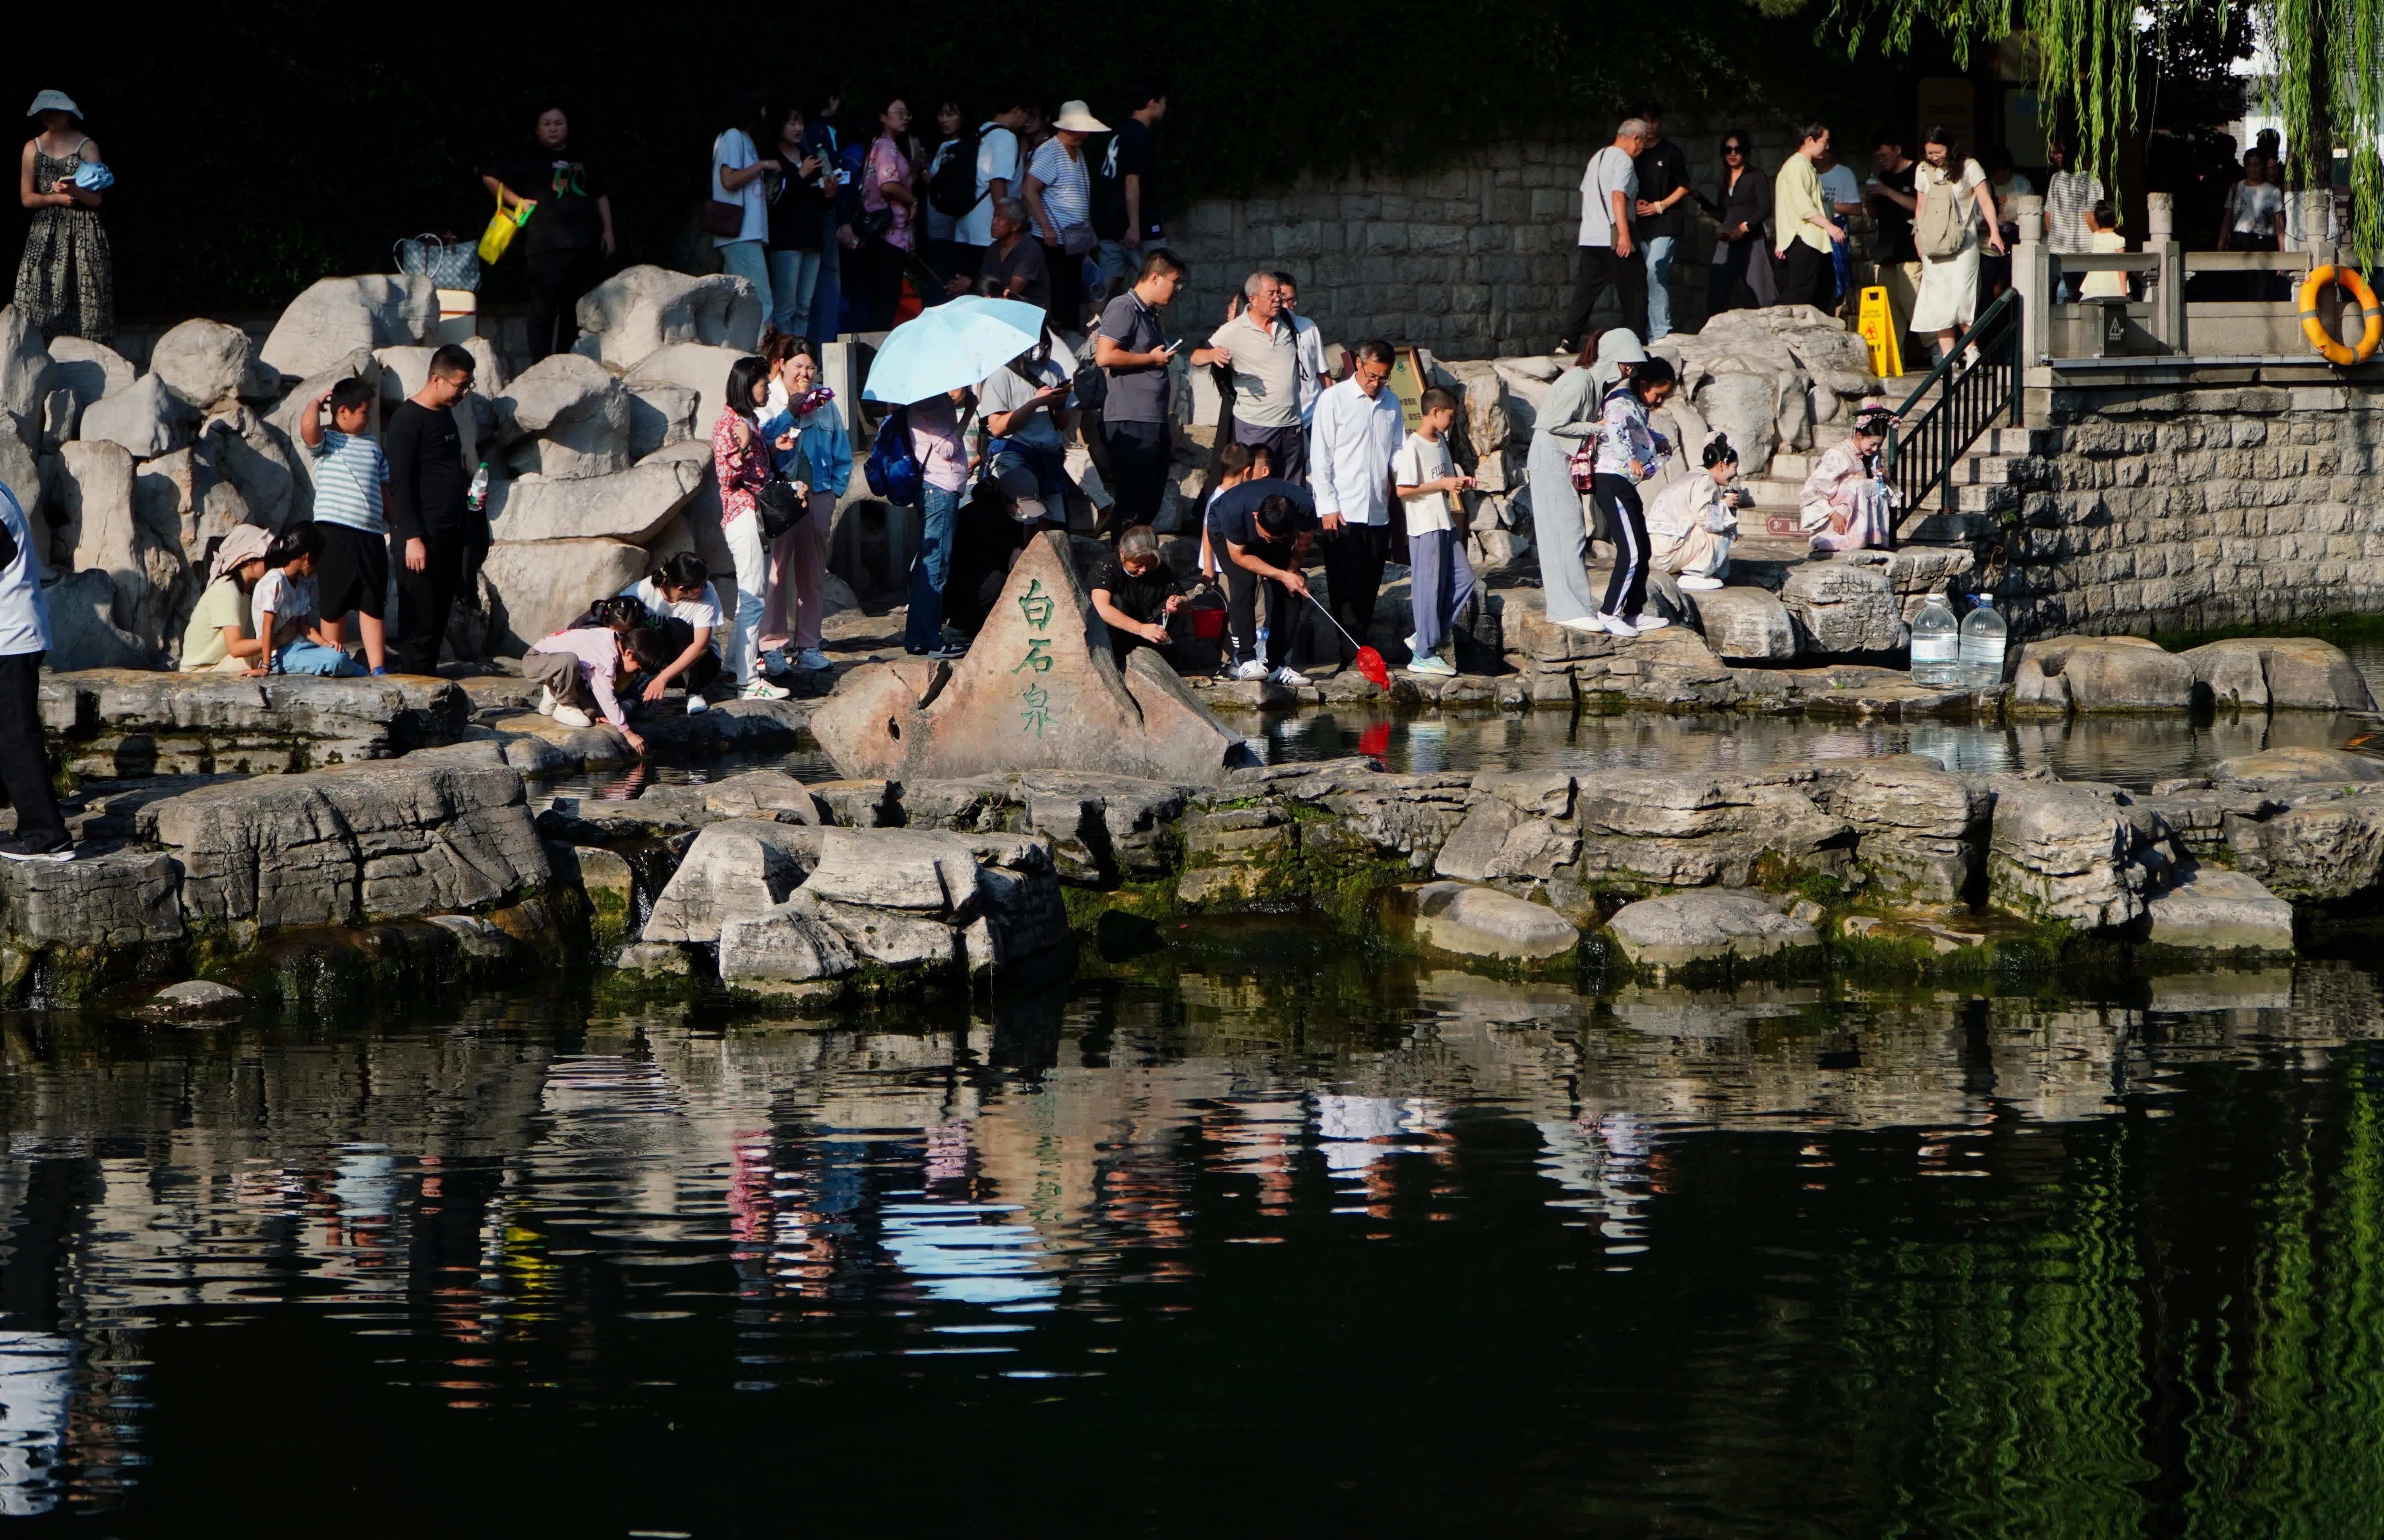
[14,958,2384,1540]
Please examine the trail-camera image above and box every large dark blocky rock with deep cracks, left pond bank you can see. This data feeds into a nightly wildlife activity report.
[141,760,551,930]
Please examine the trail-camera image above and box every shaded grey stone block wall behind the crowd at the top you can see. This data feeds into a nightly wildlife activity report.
[1168,122,1793,358]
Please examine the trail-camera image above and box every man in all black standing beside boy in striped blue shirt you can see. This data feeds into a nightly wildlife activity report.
[381,355,489,675]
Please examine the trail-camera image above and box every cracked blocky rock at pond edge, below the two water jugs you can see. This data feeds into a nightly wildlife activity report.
[1814,753,1993,903]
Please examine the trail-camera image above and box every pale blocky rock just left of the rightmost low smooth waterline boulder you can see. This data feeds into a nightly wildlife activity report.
[1986,777,2150,930]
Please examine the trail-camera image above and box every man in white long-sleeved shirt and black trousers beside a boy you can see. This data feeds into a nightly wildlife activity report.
[1309,341,1402,665]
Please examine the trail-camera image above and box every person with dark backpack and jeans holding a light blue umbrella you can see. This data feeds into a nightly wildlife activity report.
[861,296,1044,658]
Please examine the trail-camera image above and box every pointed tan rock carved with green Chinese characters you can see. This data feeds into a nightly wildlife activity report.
[811,536,1247,784]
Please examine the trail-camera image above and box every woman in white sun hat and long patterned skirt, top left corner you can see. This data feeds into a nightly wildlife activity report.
[17,91,117,343]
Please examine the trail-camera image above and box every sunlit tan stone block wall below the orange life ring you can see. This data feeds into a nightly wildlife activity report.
[1988,384,2384,637]
